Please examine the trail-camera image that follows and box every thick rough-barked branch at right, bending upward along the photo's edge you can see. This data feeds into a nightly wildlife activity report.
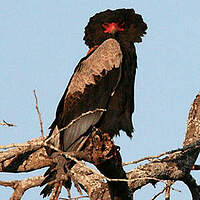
[127,94,200,197]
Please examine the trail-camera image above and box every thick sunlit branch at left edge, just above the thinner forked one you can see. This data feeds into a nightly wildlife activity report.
[0,137,51,173]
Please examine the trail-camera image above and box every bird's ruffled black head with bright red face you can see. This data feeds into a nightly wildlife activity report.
[84,9,147,48]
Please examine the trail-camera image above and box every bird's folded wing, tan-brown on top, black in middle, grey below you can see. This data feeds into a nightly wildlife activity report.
[51,39,122,151]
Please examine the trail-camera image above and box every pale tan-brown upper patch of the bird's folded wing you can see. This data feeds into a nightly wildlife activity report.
[66,39,122,98]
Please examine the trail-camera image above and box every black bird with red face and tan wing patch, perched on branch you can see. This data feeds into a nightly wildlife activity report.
[40,9,147,197]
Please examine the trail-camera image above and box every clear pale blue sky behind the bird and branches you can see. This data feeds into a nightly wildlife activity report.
[0,0,200,200]
